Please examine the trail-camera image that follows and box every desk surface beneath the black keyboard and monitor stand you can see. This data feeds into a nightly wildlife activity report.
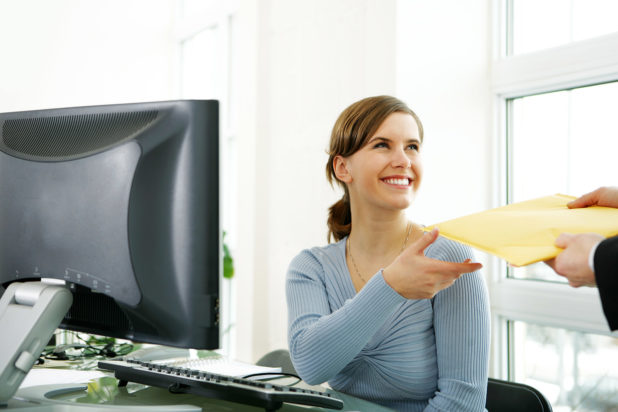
[6,362,392,412]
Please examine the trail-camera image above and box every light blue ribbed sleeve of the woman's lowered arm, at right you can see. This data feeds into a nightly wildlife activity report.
[425,241,490,412]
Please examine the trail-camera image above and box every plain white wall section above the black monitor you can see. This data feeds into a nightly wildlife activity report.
[0,0,176,112]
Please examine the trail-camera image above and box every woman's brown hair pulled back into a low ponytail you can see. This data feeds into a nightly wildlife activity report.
[326,96,423,242]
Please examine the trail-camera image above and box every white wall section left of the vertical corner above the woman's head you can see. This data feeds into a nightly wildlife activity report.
[232,0,395,360]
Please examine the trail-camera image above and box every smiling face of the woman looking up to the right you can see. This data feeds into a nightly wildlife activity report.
[342,112,422,210]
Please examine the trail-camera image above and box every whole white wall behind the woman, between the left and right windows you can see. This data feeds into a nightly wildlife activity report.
[237,0,493,360]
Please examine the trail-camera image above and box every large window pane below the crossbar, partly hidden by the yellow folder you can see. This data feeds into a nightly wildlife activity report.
[509,81,618,282]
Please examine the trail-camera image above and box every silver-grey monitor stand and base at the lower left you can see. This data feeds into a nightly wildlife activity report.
[0,280,202,412]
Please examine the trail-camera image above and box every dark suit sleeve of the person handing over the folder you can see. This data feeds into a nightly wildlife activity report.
[594,236,618,330]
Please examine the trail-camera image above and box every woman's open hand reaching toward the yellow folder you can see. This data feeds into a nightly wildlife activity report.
[382,228,482,299]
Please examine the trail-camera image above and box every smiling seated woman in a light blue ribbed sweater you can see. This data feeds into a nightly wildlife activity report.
[286,96,489,412]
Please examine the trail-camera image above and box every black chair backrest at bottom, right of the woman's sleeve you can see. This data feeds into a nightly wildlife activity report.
[485,378,552,412]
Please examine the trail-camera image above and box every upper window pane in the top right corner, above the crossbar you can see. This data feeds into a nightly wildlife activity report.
[511,0,618,54]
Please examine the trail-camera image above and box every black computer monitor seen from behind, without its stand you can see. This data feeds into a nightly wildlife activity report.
[0,100,221,349]
